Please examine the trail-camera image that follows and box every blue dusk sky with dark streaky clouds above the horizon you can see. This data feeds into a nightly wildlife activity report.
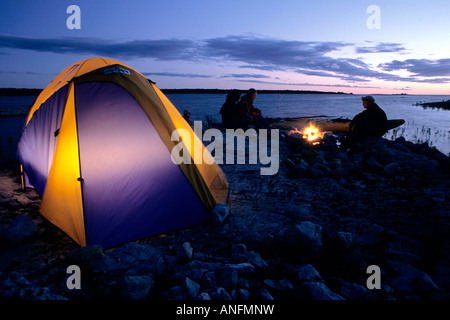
[0,0,450,94]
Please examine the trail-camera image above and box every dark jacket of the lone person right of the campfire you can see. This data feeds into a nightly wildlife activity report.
[349,103,387,138]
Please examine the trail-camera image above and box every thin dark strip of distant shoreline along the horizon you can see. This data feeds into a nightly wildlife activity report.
[0,88,353,96]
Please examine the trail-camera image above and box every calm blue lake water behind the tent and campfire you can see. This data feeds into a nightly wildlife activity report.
[0,93,450,155]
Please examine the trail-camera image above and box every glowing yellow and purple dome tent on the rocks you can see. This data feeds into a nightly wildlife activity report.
[17,58,228,248]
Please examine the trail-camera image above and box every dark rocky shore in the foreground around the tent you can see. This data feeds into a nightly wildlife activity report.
[0,129,450,301]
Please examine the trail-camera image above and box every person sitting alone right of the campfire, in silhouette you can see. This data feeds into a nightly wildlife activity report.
[341,96,387,149]
